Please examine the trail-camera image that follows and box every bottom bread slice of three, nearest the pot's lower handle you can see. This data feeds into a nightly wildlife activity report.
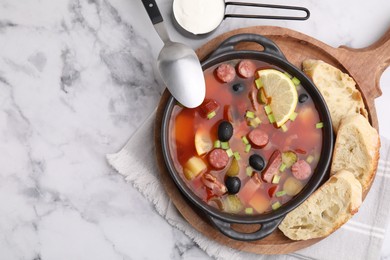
[279,170,362,240]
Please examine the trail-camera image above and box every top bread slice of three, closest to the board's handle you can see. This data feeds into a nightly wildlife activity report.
[303,60,368,132]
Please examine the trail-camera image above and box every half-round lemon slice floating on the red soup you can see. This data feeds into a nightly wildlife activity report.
[257,69,298,127]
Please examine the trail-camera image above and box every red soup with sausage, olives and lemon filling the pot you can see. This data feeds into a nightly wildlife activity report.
[168,59,323,215]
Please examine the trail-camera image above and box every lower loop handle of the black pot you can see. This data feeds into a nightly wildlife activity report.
[208,216,284,241]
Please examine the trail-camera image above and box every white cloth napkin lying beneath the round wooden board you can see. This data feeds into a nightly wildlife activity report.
[107,112,390,260]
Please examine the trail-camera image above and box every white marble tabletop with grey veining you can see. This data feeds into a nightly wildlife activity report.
[0,0,390,260]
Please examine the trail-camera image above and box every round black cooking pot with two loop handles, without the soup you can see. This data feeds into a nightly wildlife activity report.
[161,34,333,241]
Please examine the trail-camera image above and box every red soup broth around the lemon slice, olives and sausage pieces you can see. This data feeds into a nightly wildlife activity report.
[169,60,322,214]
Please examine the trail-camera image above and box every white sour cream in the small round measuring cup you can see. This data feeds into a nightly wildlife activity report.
[173,0,225,34]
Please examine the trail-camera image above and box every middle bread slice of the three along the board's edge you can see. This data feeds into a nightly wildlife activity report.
[330,114,380,192]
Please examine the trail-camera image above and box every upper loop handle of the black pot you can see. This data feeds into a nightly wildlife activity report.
[208,33,286,60]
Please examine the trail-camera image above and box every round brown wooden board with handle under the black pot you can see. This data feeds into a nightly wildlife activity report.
[155,26,390,254]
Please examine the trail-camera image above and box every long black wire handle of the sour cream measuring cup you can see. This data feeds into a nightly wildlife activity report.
[225,2,310,20]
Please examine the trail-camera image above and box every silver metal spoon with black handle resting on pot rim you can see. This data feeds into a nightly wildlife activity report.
[142,0,206,108]
